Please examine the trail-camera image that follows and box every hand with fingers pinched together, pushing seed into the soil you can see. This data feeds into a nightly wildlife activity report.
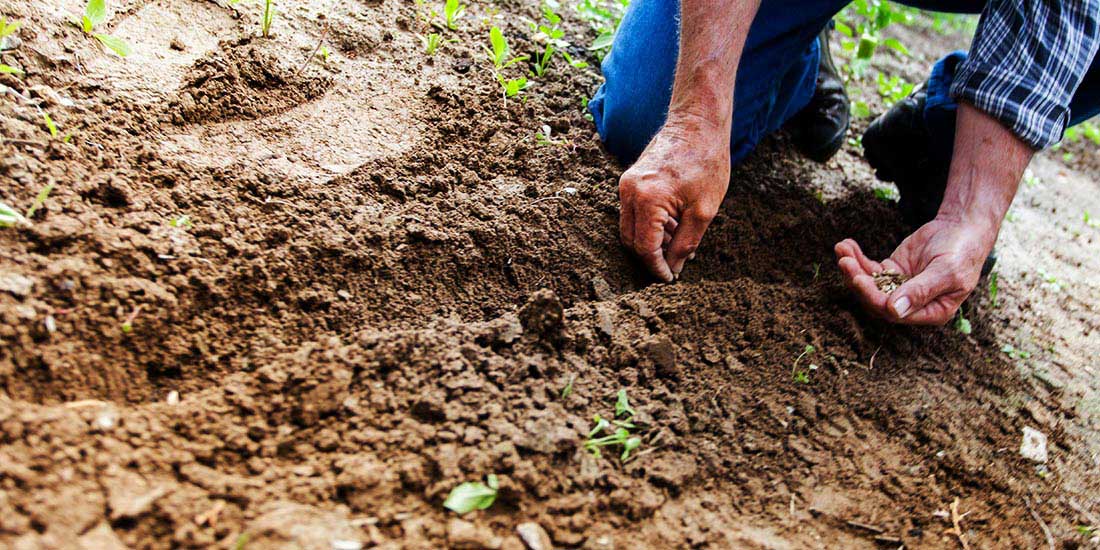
[619,117,729,283]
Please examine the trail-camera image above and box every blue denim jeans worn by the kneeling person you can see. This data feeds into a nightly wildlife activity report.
[589,0,1100,164]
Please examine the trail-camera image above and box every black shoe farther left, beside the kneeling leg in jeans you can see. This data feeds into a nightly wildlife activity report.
[789,26,850,163]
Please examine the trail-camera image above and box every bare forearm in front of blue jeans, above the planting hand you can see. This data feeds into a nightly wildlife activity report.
[669,0,760,134]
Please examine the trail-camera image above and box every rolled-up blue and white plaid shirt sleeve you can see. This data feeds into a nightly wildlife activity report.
[950,0,1100,149]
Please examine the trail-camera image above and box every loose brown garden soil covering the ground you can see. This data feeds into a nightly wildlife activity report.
[0,0,1100,549]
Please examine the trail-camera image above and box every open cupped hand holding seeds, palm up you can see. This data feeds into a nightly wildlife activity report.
[835,218,999,325]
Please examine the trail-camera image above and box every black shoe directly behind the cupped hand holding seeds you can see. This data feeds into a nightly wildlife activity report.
[864,90,997,276]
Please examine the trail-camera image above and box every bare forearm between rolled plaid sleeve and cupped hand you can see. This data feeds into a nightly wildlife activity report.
[938,103,1035,238]
